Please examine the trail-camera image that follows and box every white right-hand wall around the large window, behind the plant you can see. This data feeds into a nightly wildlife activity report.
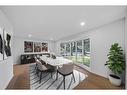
[56,19,124,77]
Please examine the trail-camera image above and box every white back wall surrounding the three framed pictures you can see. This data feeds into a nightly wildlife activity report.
[13,37,55,64]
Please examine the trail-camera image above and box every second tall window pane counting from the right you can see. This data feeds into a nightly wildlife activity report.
[77,40,83,63]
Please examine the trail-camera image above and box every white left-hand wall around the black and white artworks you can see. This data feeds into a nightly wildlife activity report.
[0,10,13,89]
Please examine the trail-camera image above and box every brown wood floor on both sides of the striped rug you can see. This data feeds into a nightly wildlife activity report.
[6,64,124,90]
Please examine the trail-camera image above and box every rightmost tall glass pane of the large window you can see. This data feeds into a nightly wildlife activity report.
[83,39,90,67]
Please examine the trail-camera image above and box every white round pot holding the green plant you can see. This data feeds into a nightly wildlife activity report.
[109,74,122,86]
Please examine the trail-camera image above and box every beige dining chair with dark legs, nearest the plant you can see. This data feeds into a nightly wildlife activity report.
[56,63,75,89]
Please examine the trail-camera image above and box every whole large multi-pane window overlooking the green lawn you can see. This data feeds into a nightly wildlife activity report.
[60,39,90,67]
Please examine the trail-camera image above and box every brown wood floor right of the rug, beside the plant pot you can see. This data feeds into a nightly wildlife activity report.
[74,66,124,90]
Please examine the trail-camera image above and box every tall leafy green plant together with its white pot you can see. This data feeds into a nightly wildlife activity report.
[105,43,125,86]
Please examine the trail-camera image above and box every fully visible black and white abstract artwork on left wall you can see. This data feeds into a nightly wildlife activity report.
[3,30,11,59]
